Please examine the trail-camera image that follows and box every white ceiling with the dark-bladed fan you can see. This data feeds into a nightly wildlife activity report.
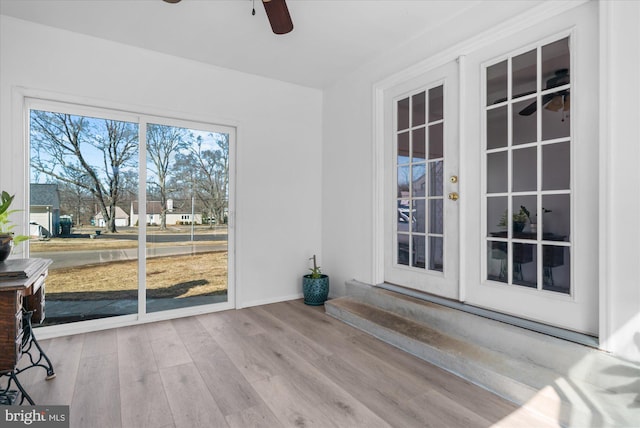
[0,0,535,88]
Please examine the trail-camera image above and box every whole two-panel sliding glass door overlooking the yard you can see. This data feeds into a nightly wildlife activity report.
[29,101,233,324]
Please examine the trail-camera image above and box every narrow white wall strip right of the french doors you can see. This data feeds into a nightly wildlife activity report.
[600,1,640,361]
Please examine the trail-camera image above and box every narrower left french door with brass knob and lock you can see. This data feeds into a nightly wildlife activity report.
[385,62,458,298]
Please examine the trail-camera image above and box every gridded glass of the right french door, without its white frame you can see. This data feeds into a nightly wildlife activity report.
[485,37,573,294]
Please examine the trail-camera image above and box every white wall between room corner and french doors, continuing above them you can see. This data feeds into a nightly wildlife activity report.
[322,1,552,295]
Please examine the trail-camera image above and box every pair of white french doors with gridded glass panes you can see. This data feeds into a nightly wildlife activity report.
[383,0,598,335]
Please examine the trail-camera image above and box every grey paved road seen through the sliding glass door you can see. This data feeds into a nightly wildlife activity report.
[31,243,227,268]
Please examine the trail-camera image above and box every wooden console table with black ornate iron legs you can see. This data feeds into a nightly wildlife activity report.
[0,258,55,404]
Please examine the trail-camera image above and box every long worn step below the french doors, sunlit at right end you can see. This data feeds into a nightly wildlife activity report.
[325,282,640,426]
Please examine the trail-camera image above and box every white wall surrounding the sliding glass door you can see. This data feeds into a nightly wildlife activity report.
[0,16,322,307]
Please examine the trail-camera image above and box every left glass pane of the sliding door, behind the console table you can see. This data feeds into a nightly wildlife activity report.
[29,110,139,325]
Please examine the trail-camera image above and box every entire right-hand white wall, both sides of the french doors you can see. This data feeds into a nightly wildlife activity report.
[322,1,640,361]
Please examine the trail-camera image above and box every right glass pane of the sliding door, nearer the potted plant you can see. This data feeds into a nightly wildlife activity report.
[146,124,229,312]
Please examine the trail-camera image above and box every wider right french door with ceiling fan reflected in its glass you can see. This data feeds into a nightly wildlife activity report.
[463,6,598,335]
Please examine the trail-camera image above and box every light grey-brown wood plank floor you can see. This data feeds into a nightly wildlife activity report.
[15,301,555,428]
